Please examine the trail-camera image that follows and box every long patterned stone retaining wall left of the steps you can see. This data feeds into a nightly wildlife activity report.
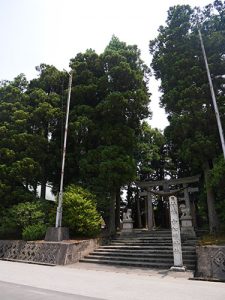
[0,239,102,265]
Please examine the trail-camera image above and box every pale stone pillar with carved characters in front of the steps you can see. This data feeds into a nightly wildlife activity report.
[169,196,186,271]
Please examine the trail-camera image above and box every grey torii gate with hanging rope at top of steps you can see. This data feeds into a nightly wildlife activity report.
[135,175,200,230]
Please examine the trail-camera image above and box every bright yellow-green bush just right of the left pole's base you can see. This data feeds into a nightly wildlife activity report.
[63,185,101,237]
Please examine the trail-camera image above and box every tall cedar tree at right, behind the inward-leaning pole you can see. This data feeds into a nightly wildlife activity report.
[150,1,225,232]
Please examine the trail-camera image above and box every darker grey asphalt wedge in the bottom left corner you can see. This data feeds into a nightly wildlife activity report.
[0,281,102,300]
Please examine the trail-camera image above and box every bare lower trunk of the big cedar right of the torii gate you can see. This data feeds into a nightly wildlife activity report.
[203,161,219,233]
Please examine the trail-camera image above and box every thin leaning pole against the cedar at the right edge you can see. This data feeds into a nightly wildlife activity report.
[198,27,225,159]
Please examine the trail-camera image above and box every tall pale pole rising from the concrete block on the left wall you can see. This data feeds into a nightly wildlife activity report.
[55,72,72,228]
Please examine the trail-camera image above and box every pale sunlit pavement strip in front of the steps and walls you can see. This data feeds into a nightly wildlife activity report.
[0,261,225,300]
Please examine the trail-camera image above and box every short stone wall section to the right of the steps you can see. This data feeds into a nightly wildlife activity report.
[196,245,225,280]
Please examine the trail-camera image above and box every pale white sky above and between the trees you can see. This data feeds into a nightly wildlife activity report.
[0,0,212,130]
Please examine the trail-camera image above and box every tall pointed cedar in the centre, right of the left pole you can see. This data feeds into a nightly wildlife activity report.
[68,37,149,233]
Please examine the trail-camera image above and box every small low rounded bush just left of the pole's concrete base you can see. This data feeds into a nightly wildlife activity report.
[22,223,47,241]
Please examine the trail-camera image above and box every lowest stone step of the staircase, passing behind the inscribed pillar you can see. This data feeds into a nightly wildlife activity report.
[80,258,195,270]
